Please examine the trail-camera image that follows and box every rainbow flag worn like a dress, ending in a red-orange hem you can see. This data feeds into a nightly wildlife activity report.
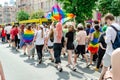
[88,32,100,54]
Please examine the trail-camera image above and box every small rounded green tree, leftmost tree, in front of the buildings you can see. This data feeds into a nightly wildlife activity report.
[17,10,29,21]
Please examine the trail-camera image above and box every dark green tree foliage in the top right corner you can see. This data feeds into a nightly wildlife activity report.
[98,0,120,16]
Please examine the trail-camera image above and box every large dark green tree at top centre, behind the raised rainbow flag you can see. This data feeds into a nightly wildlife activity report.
[57,0,98,23]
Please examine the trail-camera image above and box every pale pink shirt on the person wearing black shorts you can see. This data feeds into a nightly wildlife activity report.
[76,30,87,45]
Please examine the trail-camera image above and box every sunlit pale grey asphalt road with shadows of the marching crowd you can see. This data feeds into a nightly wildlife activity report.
[0,44,100,80]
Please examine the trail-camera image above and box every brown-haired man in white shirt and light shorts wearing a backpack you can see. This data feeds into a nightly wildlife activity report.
[99,14,120,80]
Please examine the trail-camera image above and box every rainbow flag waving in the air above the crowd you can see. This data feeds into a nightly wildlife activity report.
[46,4,75,23]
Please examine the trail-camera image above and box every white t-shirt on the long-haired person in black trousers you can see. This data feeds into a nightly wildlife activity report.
[35,30,44,45]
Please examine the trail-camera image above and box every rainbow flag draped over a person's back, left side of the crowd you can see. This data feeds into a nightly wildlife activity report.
[23,30,34,43]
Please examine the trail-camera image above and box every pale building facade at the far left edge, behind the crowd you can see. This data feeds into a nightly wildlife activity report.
[0,3,16,24]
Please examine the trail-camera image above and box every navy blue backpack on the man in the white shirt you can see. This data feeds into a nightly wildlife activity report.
[111,25,120,49]
